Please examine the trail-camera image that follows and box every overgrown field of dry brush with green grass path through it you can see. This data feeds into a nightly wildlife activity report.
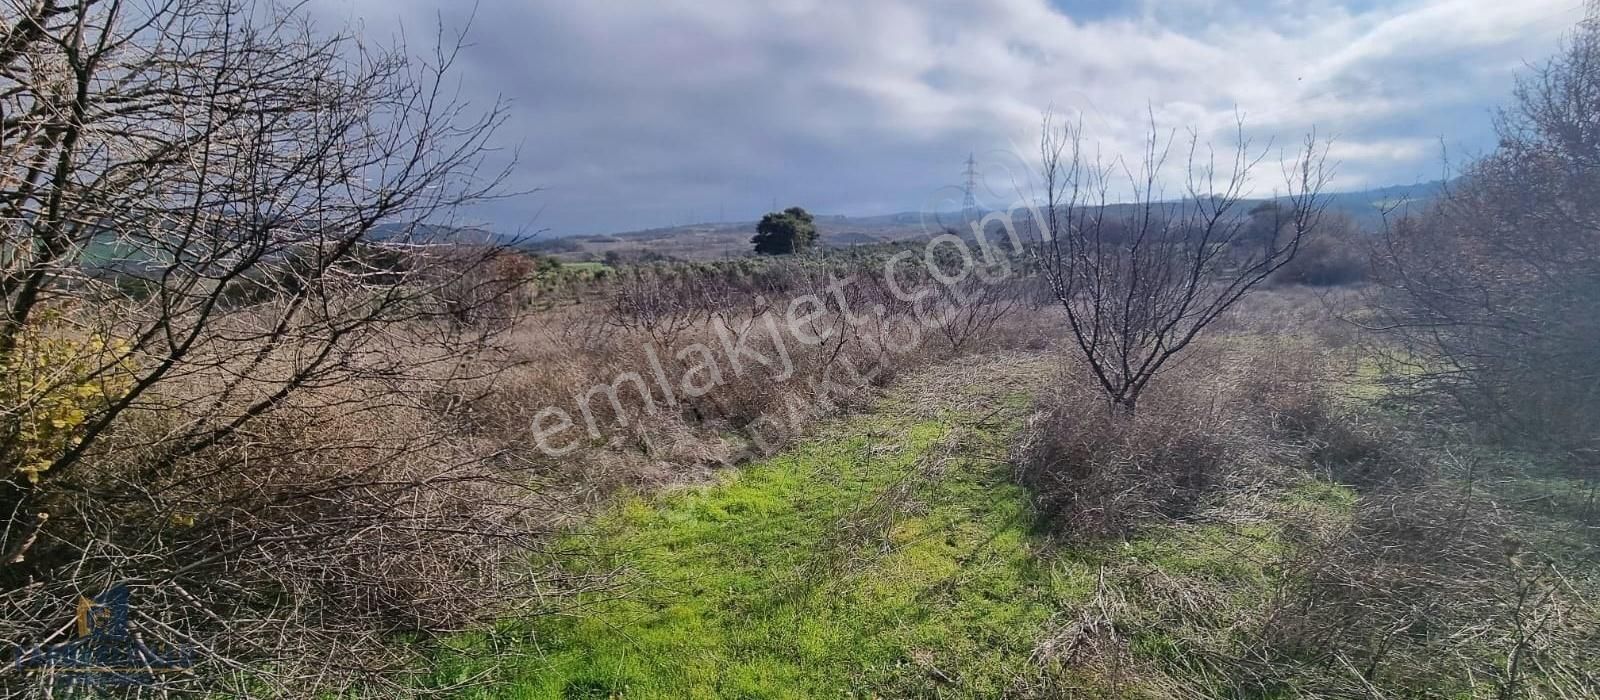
[9,222,1600,698]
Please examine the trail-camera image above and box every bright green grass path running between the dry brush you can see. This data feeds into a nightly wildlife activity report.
[442,358,1083,698]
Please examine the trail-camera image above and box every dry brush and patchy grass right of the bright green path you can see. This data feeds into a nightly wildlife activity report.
[1018,304,1600,698]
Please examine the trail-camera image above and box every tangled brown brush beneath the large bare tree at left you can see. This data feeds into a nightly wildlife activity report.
[5,337,570,695]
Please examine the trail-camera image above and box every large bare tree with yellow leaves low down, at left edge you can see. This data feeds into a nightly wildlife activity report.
[0,0,544,692]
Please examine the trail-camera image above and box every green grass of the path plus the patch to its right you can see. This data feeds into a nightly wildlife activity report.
[419,345,1595,698]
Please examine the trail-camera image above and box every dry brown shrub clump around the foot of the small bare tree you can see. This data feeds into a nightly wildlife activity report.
[1016,337,1331,535]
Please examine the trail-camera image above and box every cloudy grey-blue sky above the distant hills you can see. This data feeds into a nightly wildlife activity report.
[314,0,1584,235]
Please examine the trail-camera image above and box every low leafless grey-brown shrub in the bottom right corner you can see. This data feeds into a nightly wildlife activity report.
[1258,484,1600,698]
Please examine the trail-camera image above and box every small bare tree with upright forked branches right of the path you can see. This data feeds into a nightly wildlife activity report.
[1030,115,1331,414]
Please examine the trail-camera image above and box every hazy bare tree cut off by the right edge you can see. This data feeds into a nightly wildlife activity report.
[1374,10,1600,463]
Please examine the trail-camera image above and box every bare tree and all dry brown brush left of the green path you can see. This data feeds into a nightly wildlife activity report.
[0,0,1016,697]
